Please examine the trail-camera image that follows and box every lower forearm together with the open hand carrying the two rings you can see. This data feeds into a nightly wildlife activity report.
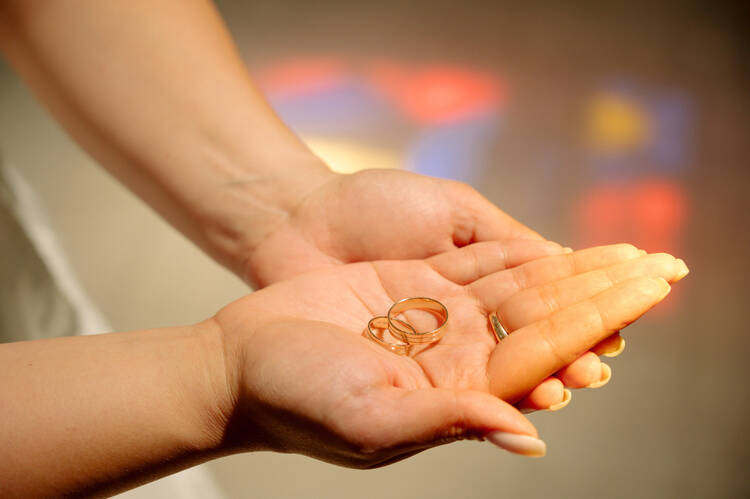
[0,243,684,497]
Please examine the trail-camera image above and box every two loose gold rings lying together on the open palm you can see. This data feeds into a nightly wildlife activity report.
[365,296,448,355]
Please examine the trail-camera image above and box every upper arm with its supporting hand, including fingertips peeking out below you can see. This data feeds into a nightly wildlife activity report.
[0,0,636,409]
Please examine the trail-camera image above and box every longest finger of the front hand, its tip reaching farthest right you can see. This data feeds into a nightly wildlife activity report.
[496,253,688,331]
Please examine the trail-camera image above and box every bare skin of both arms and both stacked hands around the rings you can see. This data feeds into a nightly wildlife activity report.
[0,4,687,497]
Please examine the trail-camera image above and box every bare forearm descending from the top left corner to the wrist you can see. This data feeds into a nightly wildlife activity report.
[0,0,331,280]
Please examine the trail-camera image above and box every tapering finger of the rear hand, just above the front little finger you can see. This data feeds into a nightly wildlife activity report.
[447,182,544,246]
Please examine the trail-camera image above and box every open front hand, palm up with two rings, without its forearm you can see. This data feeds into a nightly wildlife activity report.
[215,242,686,468]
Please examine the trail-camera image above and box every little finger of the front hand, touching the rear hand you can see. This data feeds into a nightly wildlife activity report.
[427,239,569,284]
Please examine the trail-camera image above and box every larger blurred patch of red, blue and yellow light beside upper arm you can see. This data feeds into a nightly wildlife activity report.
[259,58,505,183]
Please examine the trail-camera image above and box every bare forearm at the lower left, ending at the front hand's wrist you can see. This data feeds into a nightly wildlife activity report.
[0,321,231,497]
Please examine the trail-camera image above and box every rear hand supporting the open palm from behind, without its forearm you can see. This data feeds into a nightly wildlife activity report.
[241,170,548,287]
